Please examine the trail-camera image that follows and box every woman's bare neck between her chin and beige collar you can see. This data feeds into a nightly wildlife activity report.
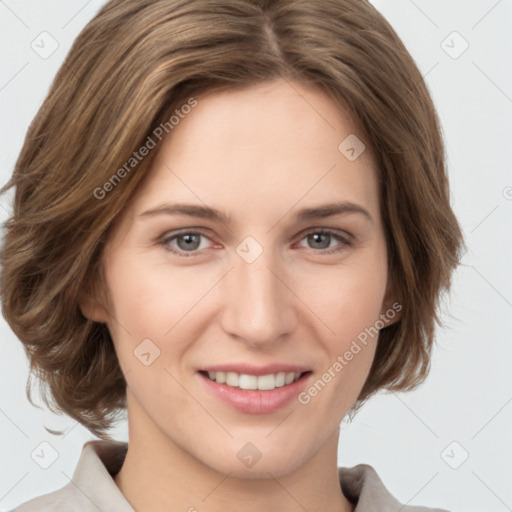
[114,400,354,512]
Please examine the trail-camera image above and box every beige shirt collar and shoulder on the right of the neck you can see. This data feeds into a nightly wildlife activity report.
[338,464,448,512]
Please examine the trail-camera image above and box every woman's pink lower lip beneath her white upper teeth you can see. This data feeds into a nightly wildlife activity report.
[199,373,311,414]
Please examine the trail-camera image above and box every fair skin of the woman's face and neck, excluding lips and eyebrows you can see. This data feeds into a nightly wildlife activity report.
[82,80,398,512]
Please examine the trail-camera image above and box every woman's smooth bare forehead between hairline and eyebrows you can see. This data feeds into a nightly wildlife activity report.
[125,80,378,228]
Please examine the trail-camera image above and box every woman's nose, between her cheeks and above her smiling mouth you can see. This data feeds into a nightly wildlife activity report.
[221,251,297,348]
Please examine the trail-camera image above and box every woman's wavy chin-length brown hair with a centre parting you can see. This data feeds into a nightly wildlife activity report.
[0,0,463,438]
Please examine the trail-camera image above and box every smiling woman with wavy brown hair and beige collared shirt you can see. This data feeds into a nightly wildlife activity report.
[2,0,462,512]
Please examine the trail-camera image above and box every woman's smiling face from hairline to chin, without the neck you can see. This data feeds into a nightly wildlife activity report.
[88,80,389,478]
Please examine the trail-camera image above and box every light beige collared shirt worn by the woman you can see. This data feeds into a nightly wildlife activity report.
[13,440,447,512]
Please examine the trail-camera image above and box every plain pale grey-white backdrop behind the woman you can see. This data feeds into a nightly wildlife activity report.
[0,0,512,512]
